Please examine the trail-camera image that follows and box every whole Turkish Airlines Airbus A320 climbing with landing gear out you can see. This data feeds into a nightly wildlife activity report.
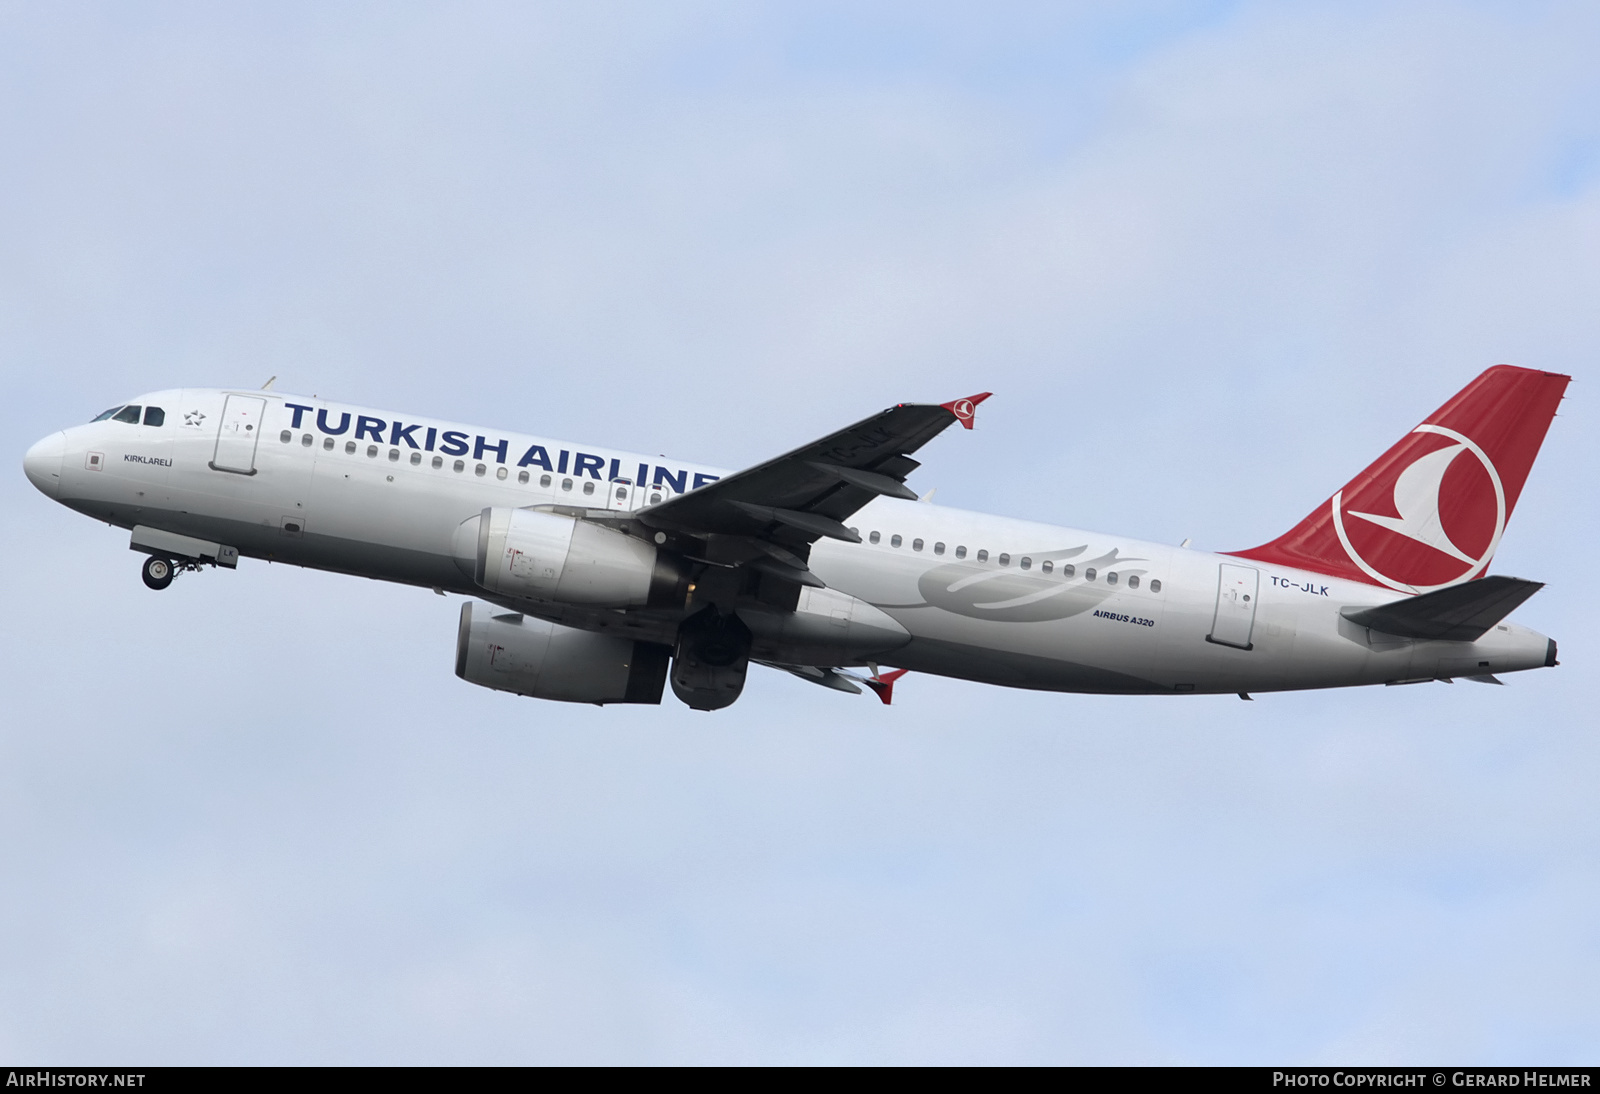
[24,365,1570,710]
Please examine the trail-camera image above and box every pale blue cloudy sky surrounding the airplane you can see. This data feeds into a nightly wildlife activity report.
[0,3,1600,1064]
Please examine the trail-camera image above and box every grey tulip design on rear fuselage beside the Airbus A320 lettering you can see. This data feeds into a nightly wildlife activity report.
[878,545,1146,622]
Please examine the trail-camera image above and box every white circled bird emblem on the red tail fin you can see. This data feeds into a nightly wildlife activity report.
[1333,425,1507,592]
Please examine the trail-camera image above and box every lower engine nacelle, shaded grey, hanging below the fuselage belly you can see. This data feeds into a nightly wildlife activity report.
[456,600,672,704]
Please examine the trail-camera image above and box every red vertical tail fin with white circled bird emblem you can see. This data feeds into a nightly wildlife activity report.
[1230,365,1568,592]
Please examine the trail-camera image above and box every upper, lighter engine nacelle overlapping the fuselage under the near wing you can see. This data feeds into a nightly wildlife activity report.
[458,509,688,608]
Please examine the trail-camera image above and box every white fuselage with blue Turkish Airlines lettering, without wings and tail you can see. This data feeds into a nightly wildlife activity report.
[27,389,1550,694]
